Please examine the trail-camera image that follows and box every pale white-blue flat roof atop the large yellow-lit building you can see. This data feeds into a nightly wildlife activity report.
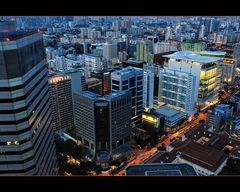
[163,51,221,63]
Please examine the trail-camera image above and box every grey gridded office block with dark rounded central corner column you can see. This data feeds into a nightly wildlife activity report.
[74,91,131,155]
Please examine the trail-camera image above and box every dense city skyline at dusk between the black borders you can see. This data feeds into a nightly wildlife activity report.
[0,16,240,176]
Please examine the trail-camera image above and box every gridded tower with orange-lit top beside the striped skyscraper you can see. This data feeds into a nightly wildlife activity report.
[49,74,74,135]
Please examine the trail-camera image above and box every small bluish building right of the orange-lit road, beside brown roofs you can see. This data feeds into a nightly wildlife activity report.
[206,104,233,131]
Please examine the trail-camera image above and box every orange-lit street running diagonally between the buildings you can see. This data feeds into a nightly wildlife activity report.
[101,113,207,176]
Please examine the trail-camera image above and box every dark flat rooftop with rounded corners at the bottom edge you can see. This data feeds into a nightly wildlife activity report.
[125,163,197,176]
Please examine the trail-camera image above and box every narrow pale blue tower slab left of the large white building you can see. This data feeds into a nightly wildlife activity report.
[143,71,154,108]
